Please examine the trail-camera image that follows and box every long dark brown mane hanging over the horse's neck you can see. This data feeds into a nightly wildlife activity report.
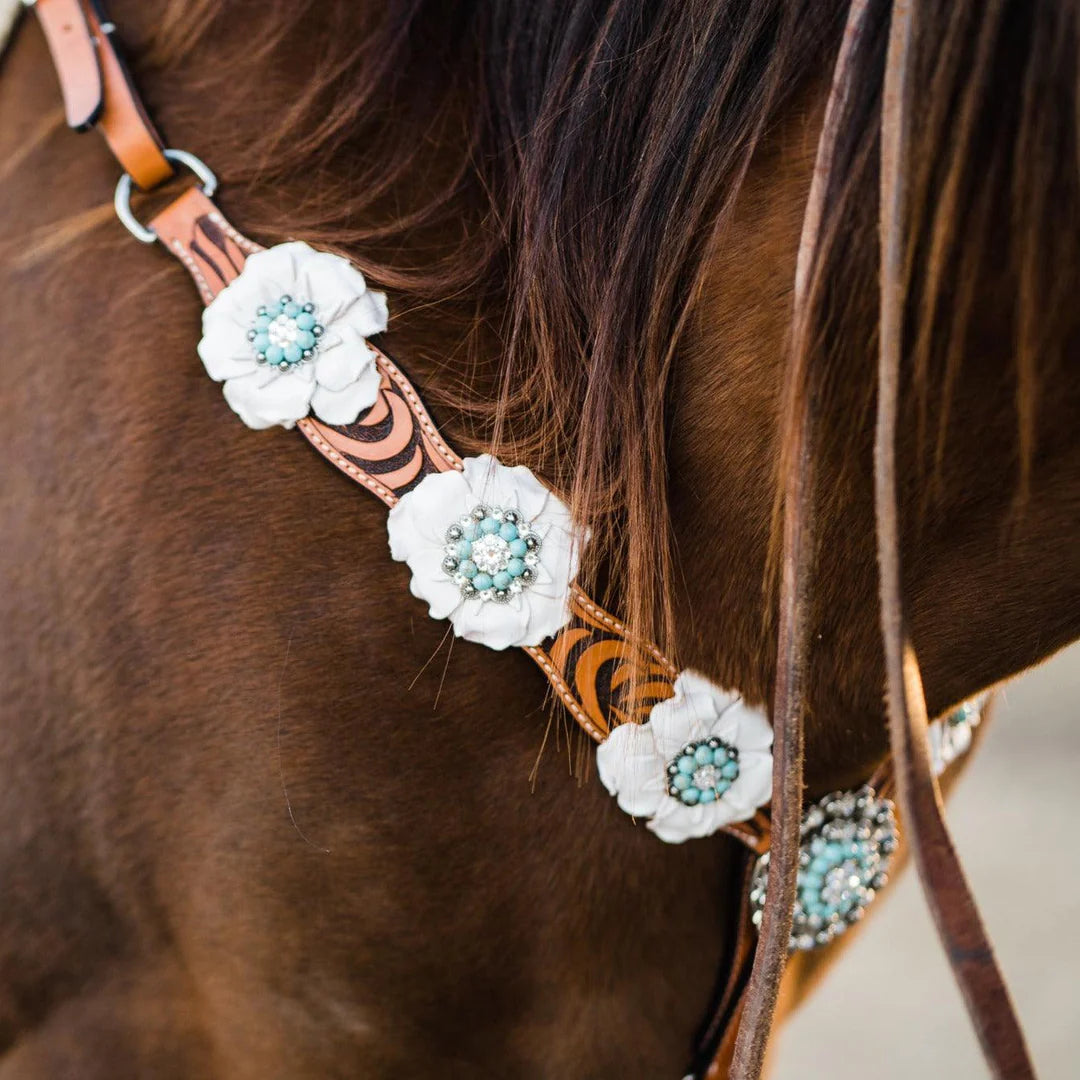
[149,0,1080,673]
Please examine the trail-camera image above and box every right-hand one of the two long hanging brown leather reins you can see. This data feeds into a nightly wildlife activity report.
[874,0,1035,1080]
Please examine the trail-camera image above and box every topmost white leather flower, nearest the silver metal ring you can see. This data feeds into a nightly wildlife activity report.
[199,241,387,428]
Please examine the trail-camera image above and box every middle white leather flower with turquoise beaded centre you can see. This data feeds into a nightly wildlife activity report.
[387,454,586,649]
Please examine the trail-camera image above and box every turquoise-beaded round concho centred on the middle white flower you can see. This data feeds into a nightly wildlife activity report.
[443,504,540,604]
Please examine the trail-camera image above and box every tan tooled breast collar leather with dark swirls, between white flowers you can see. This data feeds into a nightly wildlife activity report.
[150,188,678,747]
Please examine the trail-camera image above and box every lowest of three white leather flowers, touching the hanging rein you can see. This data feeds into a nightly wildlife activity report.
[596,671,772,843]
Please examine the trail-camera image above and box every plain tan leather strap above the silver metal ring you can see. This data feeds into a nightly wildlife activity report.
[32,0,174,191]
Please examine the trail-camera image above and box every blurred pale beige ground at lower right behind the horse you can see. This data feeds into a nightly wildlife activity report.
[771,646,1080,1080]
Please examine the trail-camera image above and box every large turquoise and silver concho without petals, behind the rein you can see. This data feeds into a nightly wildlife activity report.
[750,787,896,951]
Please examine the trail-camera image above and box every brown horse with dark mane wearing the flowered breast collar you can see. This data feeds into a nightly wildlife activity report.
[0,0,1080,1080]
